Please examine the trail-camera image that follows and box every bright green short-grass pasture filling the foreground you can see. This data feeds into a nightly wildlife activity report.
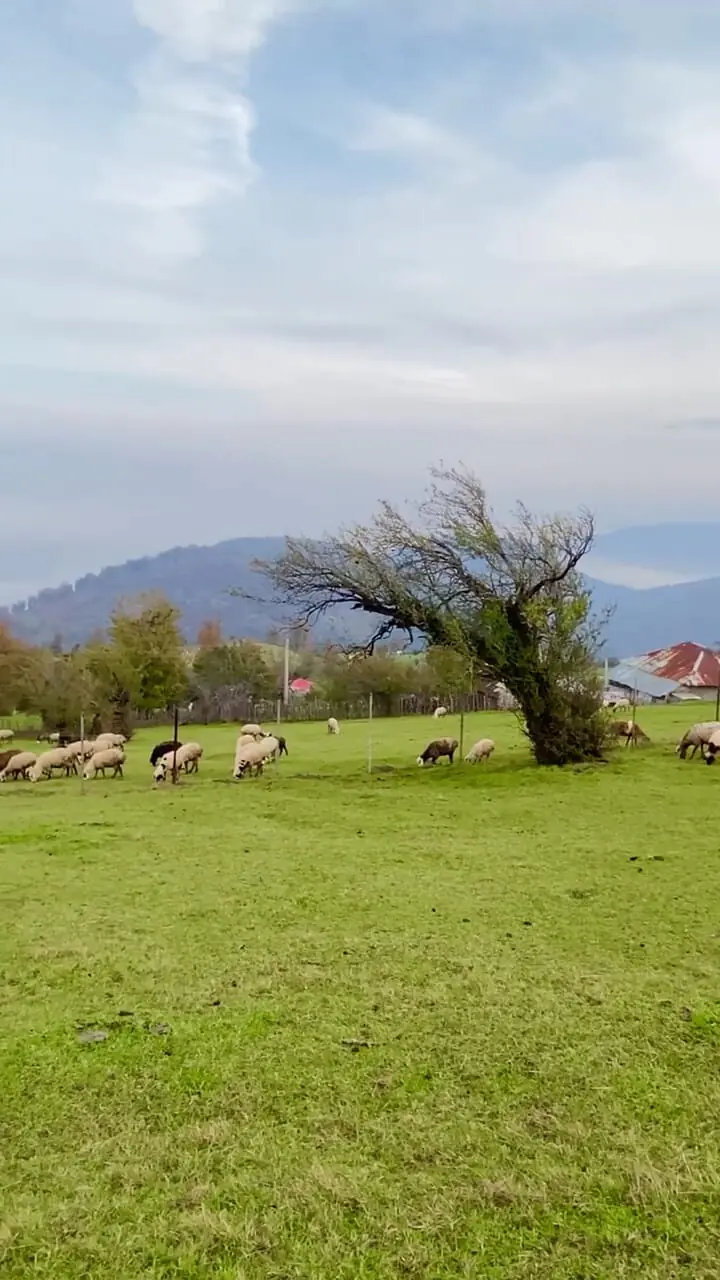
[0,707,720,1280]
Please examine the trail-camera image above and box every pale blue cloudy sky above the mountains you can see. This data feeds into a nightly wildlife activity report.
[0,0,720,603]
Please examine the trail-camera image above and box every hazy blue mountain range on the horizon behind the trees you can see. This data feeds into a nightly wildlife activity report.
[0,525,720,657]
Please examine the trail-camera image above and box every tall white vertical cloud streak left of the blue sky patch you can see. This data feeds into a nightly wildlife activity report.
[99,0,295,260]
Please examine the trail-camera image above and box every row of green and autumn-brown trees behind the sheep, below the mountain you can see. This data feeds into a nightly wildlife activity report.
[0,595,487,736]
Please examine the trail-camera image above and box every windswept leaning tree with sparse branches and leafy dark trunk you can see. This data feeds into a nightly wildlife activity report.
[256,468,606,764]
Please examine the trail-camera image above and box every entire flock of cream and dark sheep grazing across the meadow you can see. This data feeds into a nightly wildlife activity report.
[0,707,720,783]
